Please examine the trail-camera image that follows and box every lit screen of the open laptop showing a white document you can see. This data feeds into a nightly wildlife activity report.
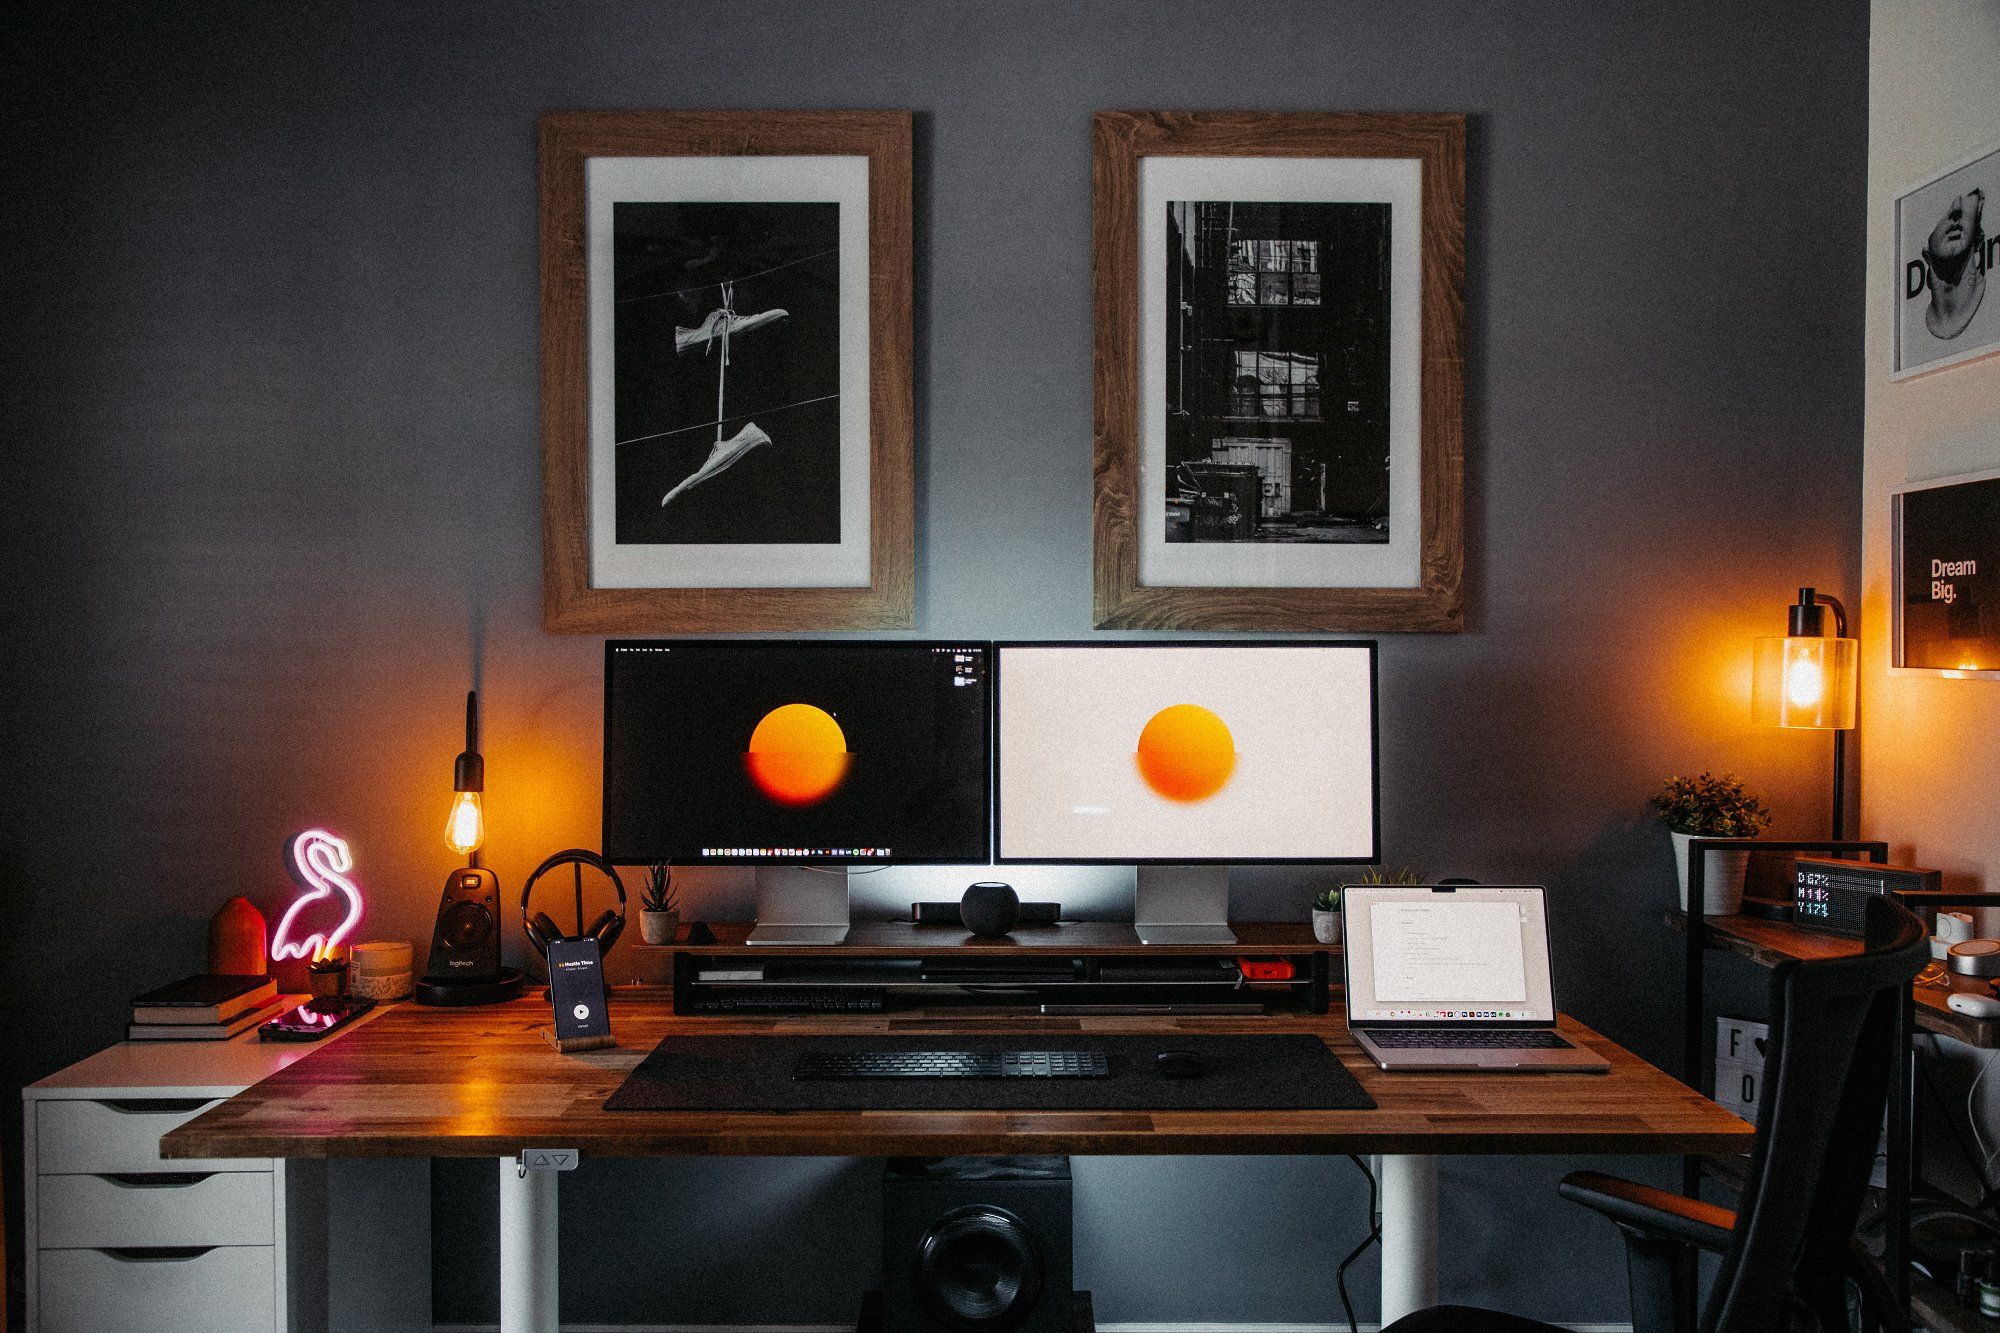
[1340,885,1556,1023]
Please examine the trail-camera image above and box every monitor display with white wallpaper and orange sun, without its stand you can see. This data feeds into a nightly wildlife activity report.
[996,642,1376,863]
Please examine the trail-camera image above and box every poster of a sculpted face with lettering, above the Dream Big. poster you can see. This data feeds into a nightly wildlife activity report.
[1892,144,2000,380]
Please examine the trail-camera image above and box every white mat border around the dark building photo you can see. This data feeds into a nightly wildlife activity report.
[1138,156,1424,588]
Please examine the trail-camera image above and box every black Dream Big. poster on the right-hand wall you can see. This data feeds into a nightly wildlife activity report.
[1890,470,2000,681]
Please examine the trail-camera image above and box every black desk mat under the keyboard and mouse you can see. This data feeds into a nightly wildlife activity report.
[604,1033,1376,1111]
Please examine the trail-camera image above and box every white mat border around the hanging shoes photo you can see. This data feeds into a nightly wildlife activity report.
[584,156,872,588]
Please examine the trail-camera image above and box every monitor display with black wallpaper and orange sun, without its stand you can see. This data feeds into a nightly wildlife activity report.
[602,638,992,865]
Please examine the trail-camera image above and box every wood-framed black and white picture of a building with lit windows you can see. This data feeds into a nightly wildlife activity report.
[1094,112,1464,630]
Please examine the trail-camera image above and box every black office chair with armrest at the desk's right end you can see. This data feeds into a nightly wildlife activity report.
[1384,899,1928,1333]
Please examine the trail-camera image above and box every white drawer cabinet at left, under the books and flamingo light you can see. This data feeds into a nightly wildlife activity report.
[22,1008,344,1333]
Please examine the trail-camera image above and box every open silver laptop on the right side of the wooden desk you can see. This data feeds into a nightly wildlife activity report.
[1340,885,1610,1073]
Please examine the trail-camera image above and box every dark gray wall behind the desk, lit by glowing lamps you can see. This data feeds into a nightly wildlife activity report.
[0,0,1866,1321]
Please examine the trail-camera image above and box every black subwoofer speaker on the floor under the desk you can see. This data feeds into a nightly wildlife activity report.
[882,1157,1072,1333]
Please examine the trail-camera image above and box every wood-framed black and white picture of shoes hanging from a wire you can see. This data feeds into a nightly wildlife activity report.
[542,110,916,634]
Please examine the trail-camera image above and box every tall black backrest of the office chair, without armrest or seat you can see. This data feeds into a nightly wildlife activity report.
[1700,897,1930,1333]
